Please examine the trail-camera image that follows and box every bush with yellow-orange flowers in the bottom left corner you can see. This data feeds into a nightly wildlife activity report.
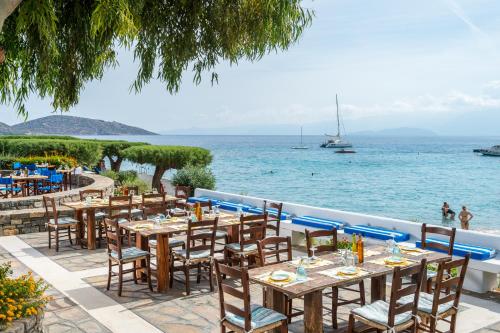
[0,263,50,330]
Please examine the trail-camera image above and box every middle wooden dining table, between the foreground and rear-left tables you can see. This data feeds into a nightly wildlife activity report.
[120,212,244,292]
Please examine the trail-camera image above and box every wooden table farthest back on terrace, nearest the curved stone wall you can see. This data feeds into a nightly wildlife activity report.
[62,195,178,250]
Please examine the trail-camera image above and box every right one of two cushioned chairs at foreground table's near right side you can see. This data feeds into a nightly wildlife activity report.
[402,254,470,333]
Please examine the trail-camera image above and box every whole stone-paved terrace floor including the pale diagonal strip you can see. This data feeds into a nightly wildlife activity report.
[0,233,500,333]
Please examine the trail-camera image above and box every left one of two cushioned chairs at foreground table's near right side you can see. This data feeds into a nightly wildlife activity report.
[347,259,426,333]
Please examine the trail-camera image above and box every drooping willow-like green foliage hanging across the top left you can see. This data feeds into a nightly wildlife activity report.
[0,0,312,115]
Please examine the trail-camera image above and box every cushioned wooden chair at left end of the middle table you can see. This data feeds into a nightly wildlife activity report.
[104,218,153,296]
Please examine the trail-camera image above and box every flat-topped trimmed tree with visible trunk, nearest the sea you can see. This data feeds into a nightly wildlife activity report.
[123,146,212,189]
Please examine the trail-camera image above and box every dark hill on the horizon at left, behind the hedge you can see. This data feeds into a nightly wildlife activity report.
[0,115,156,135]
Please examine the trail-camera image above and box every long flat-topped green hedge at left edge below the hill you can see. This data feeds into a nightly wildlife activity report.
[0,138,102,165]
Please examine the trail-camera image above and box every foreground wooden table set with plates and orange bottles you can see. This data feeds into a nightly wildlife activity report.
[248,246,450,333]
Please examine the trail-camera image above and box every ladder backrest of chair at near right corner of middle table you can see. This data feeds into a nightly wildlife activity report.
[186,217,219,259]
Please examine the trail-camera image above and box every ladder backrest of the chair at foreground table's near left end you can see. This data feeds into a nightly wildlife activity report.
[215,261,252,332]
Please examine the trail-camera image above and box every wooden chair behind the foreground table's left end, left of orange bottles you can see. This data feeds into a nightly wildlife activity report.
[257,236,304,323]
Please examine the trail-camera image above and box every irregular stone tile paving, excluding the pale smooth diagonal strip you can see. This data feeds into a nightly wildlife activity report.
[1,233,500,333]
